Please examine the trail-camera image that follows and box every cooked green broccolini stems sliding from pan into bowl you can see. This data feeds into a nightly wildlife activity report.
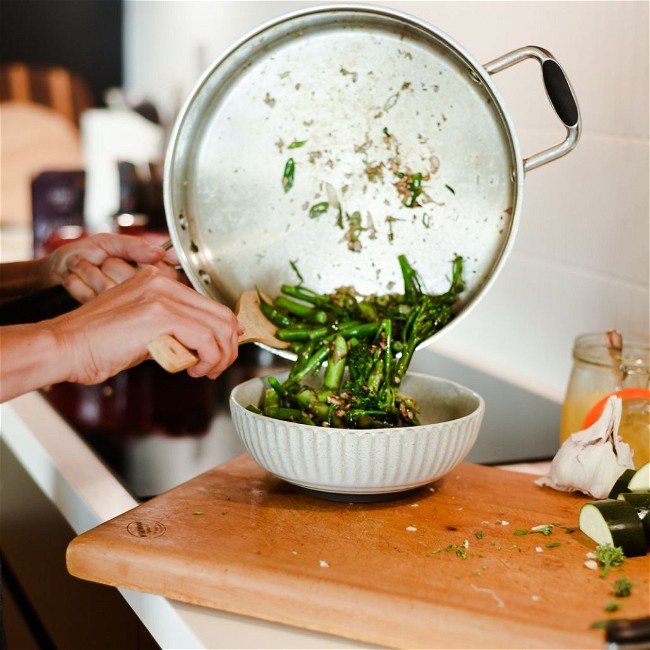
[252,255,464,429]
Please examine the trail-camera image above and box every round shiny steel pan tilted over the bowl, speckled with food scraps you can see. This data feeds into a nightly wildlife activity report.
[164,7,523,350]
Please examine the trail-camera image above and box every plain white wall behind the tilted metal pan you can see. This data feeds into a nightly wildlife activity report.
[125,0,650,401]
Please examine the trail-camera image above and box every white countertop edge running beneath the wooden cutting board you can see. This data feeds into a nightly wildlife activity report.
[0,392,374,650]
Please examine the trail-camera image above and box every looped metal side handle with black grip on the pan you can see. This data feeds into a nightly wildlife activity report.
[484,45,581,172]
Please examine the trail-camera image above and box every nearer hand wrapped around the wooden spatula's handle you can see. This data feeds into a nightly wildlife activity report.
[49,266,242,384]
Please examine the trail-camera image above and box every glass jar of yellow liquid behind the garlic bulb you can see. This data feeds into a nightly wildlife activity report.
[560,330,650,468]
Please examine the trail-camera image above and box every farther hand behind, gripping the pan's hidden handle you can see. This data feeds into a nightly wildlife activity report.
[43,233,178,303]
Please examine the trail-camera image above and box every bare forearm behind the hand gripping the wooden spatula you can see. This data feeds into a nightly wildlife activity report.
[0,323,67,402]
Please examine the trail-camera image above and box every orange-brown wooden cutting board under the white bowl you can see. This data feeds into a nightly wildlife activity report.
[67,455,650,648]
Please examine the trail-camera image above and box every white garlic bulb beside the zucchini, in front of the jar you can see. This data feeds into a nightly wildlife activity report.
[535,395,634,499]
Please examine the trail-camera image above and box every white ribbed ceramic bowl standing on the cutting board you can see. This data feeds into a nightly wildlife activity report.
[230,373,485,498]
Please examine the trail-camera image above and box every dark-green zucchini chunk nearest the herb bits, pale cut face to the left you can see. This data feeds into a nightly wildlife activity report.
[578,499,647,557]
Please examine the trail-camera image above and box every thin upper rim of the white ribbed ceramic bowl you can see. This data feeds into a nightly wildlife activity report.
[229,370,485,435]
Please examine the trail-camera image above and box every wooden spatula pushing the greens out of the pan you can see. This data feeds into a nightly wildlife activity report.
[147,291,289,372]
